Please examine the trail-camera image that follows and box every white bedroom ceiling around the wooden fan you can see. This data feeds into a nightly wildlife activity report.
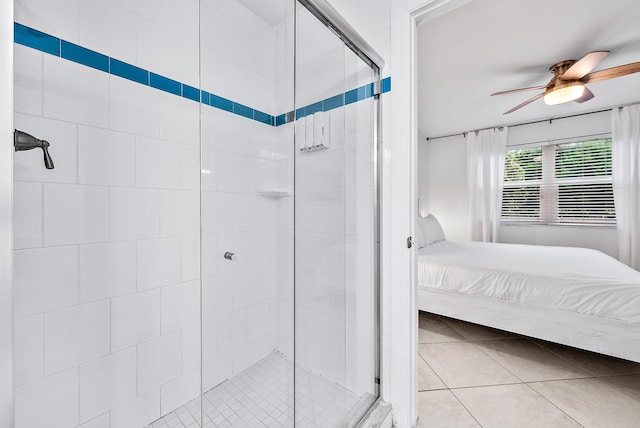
[418,0,640,137]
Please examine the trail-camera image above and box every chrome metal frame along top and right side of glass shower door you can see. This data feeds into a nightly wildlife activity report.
[293,0,385,416]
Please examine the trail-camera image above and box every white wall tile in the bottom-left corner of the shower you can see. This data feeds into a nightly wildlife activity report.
[15,367,80,428]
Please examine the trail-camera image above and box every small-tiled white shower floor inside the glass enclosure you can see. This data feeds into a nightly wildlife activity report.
[147,352,374,428]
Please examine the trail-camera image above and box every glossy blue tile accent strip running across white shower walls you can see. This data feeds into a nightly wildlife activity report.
[13,22,391,126]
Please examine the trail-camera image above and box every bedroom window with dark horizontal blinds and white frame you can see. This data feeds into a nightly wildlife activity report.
[502,138,616,224]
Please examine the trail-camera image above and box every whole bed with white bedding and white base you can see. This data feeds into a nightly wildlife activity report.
[417,217,640,362]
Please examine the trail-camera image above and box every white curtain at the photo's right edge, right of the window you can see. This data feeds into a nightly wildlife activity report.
[611,105,640,270]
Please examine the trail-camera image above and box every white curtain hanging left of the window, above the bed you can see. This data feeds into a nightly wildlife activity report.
[467,126,507,242]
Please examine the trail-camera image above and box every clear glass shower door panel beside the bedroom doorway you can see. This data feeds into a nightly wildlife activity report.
[294,4,378,427]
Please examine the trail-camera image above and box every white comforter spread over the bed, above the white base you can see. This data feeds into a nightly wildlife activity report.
[418,241,640,322]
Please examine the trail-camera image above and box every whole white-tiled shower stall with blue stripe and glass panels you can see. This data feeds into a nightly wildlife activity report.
[13,0,382,428]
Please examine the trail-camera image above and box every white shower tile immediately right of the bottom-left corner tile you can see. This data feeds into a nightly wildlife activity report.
[80,348,137,421]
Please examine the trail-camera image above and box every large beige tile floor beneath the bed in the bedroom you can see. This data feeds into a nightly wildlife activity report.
[418,312,640,428]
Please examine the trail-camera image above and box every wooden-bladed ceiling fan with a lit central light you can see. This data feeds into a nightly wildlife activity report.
[491,51,640,114]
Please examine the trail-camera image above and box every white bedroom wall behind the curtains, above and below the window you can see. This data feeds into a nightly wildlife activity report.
[418,111,617,257]
